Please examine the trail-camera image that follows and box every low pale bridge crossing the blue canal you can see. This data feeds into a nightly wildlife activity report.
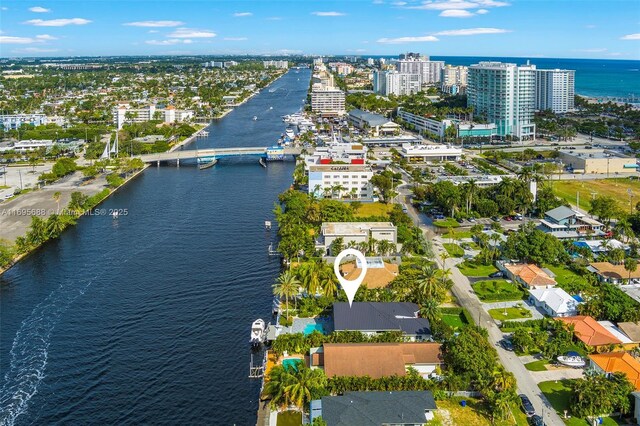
[139,147,302,164]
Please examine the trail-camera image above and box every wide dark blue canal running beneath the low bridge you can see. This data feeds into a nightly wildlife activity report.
[0,70,310,425]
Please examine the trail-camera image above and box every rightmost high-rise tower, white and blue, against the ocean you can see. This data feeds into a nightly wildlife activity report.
[536,69,575,114]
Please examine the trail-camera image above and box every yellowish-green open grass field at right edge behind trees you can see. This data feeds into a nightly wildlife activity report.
[552,178,640,211]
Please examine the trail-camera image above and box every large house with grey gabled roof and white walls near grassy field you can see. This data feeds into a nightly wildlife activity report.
[539,206,605,240]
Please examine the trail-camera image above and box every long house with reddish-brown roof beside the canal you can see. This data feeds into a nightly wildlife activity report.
[310,342,442,379]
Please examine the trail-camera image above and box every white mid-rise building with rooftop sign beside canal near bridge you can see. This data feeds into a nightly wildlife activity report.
[309,164,373,200]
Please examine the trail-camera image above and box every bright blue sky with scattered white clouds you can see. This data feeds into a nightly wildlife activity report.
[0,0,640,59]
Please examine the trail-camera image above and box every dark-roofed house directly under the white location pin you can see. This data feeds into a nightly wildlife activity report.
[333,302,431,341]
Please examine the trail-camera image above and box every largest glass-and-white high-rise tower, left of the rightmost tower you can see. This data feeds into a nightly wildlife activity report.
[467,62,536,139]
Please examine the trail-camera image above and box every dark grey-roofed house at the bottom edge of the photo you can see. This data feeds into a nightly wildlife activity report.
[311,391,437,426]
